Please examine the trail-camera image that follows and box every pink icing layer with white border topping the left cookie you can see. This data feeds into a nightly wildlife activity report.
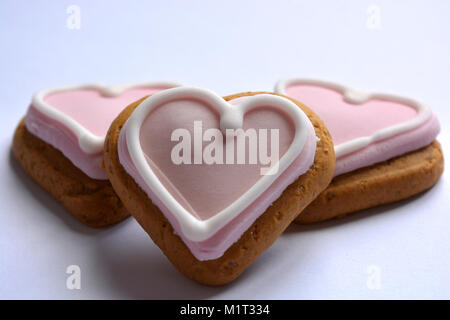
[26,82,178,179]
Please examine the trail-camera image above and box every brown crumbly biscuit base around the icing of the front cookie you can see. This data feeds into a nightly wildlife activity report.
[105,92,335,285]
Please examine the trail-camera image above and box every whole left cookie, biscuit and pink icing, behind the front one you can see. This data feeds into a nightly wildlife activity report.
[12,83,177,227]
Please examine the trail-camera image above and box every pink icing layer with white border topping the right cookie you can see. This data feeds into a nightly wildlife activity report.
[275,78,439,175]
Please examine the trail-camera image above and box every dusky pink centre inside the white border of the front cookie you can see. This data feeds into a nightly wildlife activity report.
[141,100,295,220]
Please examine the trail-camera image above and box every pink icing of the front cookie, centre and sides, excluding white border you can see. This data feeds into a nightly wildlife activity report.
[118,95,316,260]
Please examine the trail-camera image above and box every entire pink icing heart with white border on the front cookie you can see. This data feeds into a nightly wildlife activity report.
[119,87,316,250]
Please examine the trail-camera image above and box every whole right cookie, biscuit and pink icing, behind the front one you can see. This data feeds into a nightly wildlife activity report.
[275,79,444,223]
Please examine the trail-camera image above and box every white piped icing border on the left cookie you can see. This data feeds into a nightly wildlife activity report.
[31,82,181,154]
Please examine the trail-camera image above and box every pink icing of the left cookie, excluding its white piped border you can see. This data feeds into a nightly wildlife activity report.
[25,86,176,180]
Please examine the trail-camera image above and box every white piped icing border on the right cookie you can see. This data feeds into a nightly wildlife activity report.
[275,78,432,158]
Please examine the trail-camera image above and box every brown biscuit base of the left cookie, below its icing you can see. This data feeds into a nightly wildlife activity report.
[12,119,129,227]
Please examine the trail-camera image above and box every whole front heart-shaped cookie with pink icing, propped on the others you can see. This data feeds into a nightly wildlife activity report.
[105,87,335,285]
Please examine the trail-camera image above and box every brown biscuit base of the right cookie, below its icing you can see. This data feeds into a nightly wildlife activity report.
[295,141,444,224]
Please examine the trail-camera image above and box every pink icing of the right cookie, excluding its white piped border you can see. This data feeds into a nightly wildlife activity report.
[285,84,439,176]
